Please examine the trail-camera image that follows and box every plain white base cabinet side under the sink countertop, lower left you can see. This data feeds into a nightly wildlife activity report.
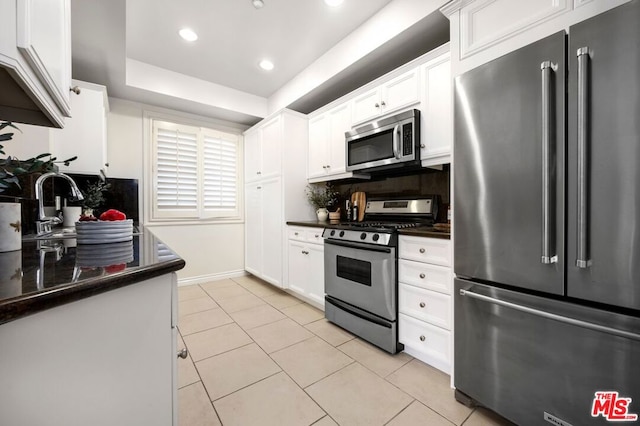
[0,273,178,426]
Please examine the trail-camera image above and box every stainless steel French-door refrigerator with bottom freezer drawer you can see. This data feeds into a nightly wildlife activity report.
[453,0,640,426]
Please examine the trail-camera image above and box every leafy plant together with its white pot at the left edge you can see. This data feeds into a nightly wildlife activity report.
[0,121,76,252]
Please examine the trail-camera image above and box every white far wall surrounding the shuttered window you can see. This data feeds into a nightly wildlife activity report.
[108,98,244,284]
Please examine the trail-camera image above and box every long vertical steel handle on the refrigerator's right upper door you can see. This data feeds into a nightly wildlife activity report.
[576,47,591,269]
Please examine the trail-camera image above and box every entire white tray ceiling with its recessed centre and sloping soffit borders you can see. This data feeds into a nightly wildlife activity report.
[71,0,448,125]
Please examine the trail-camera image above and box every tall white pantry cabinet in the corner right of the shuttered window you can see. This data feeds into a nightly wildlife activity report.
[245,110,314,287]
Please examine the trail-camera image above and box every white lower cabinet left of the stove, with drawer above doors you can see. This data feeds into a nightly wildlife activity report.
[287,226,324,308]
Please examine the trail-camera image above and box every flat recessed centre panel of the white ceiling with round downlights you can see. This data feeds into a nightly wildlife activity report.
[126,0,391,98]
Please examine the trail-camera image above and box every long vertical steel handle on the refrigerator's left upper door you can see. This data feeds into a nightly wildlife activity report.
[540,61,558,264]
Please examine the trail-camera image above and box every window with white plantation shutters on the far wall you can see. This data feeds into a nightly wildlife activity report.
[152,120,240,220]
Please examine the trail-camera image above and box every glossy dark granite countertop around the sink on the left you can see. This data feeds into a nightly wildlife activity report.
[0,229,185,324]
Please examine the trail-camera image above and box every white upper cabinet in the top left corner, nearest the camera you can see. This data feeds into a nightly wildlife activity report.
[0,0,71,127]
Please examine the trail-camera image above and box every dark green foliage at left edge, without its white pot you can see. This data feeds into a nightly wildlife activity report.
[0,121,77,193]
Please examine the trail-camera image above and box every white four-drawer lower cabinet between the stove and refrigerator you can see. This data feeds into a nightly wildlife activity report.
[398,235,453,374]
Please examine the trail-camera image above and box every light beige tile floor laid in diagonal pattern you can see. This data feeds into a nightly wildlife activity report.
[178,276,510,426]
